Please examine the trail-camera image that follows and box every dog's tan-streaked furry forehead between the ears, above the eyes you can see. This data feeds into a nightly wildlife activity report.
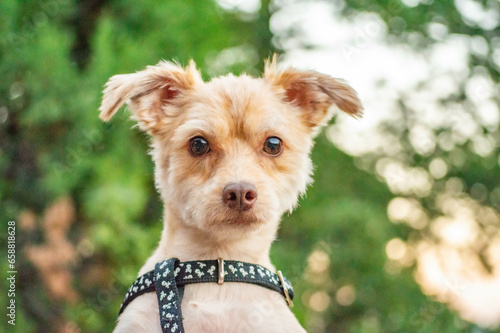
[181,75,289,137]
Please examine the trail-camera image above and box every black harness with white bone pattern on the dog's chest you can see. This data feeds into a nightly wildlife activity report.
[120,258,293,333]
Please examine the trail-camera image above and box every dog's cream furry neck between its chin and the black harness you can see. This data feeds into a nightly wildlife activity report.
[140,210,279,274]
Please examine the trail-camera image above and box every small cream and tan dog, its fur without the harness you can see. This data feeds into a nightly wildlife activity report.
[99,57,362,333]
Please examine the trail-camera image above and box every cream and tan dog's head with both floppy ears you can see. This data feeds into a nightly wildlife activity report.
[100,61,362,238]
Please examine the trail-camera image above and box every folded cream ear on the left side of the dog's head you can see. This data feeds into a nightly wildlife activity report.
[99,61,203,135]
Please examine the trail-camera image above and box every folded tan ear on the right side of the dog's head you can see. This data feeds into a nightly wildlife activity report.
[264,57,363,128]
